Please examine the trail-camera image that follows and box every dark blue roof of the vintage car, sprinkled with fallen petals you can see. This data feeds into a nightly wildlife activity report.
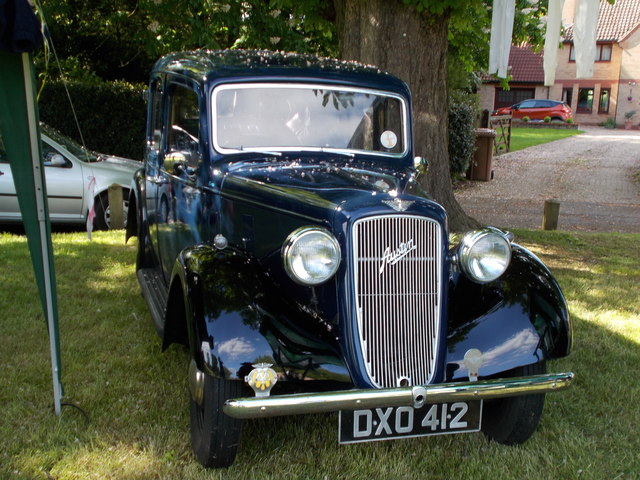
[152,50,409,96]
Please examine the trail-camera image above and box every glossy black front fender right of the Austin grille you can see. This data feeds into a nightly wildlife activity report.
[446,245,572,380]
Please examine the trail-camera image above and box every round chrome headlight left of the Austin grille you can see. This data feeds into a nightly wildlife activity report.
[282,227,340,285]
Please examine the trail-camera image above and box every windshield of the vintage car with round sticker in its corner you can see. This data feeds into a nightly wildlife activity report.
[212,84,407,156]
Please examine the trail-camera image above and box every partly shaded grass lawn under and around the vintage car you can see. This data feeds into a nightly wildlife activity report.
[0,231,640,480]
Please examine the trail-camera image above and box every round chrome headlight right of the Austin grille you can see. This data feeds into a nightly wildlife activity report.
[458,227,511,283]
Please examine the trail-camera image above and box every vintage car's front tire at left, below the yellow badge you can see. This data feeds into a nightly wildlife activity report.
[190,365,242,468]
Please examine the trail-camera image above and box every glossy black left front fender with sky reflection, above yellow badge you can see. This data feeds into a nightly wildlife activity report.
[169,244,349,382]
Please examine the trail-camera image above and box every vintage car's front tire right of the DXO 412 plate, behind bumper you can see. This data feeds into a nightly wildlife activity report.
[482,362,547,445]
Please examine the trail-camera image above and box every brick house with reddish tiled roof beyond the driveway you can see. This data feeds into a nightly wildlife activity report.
[479,0,640,126]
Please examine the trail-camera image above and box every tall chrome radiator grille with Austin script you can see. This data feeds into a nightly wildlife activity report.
[352,215,442,388]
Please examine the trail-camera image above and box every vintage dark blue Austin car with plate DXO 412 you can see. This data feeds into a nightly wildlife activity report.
[127,51,573,467]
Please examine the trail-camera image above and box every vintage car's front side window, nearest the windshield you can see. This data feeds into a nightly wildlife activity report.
[165,85,202,167]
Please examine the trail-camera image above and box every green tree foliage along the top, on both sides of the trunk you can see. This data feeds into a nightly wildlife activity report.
[41,0,548,82]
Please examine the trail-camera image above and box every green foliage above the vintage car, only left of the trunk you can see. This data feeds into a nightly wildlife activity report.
[40,0,337,82]
